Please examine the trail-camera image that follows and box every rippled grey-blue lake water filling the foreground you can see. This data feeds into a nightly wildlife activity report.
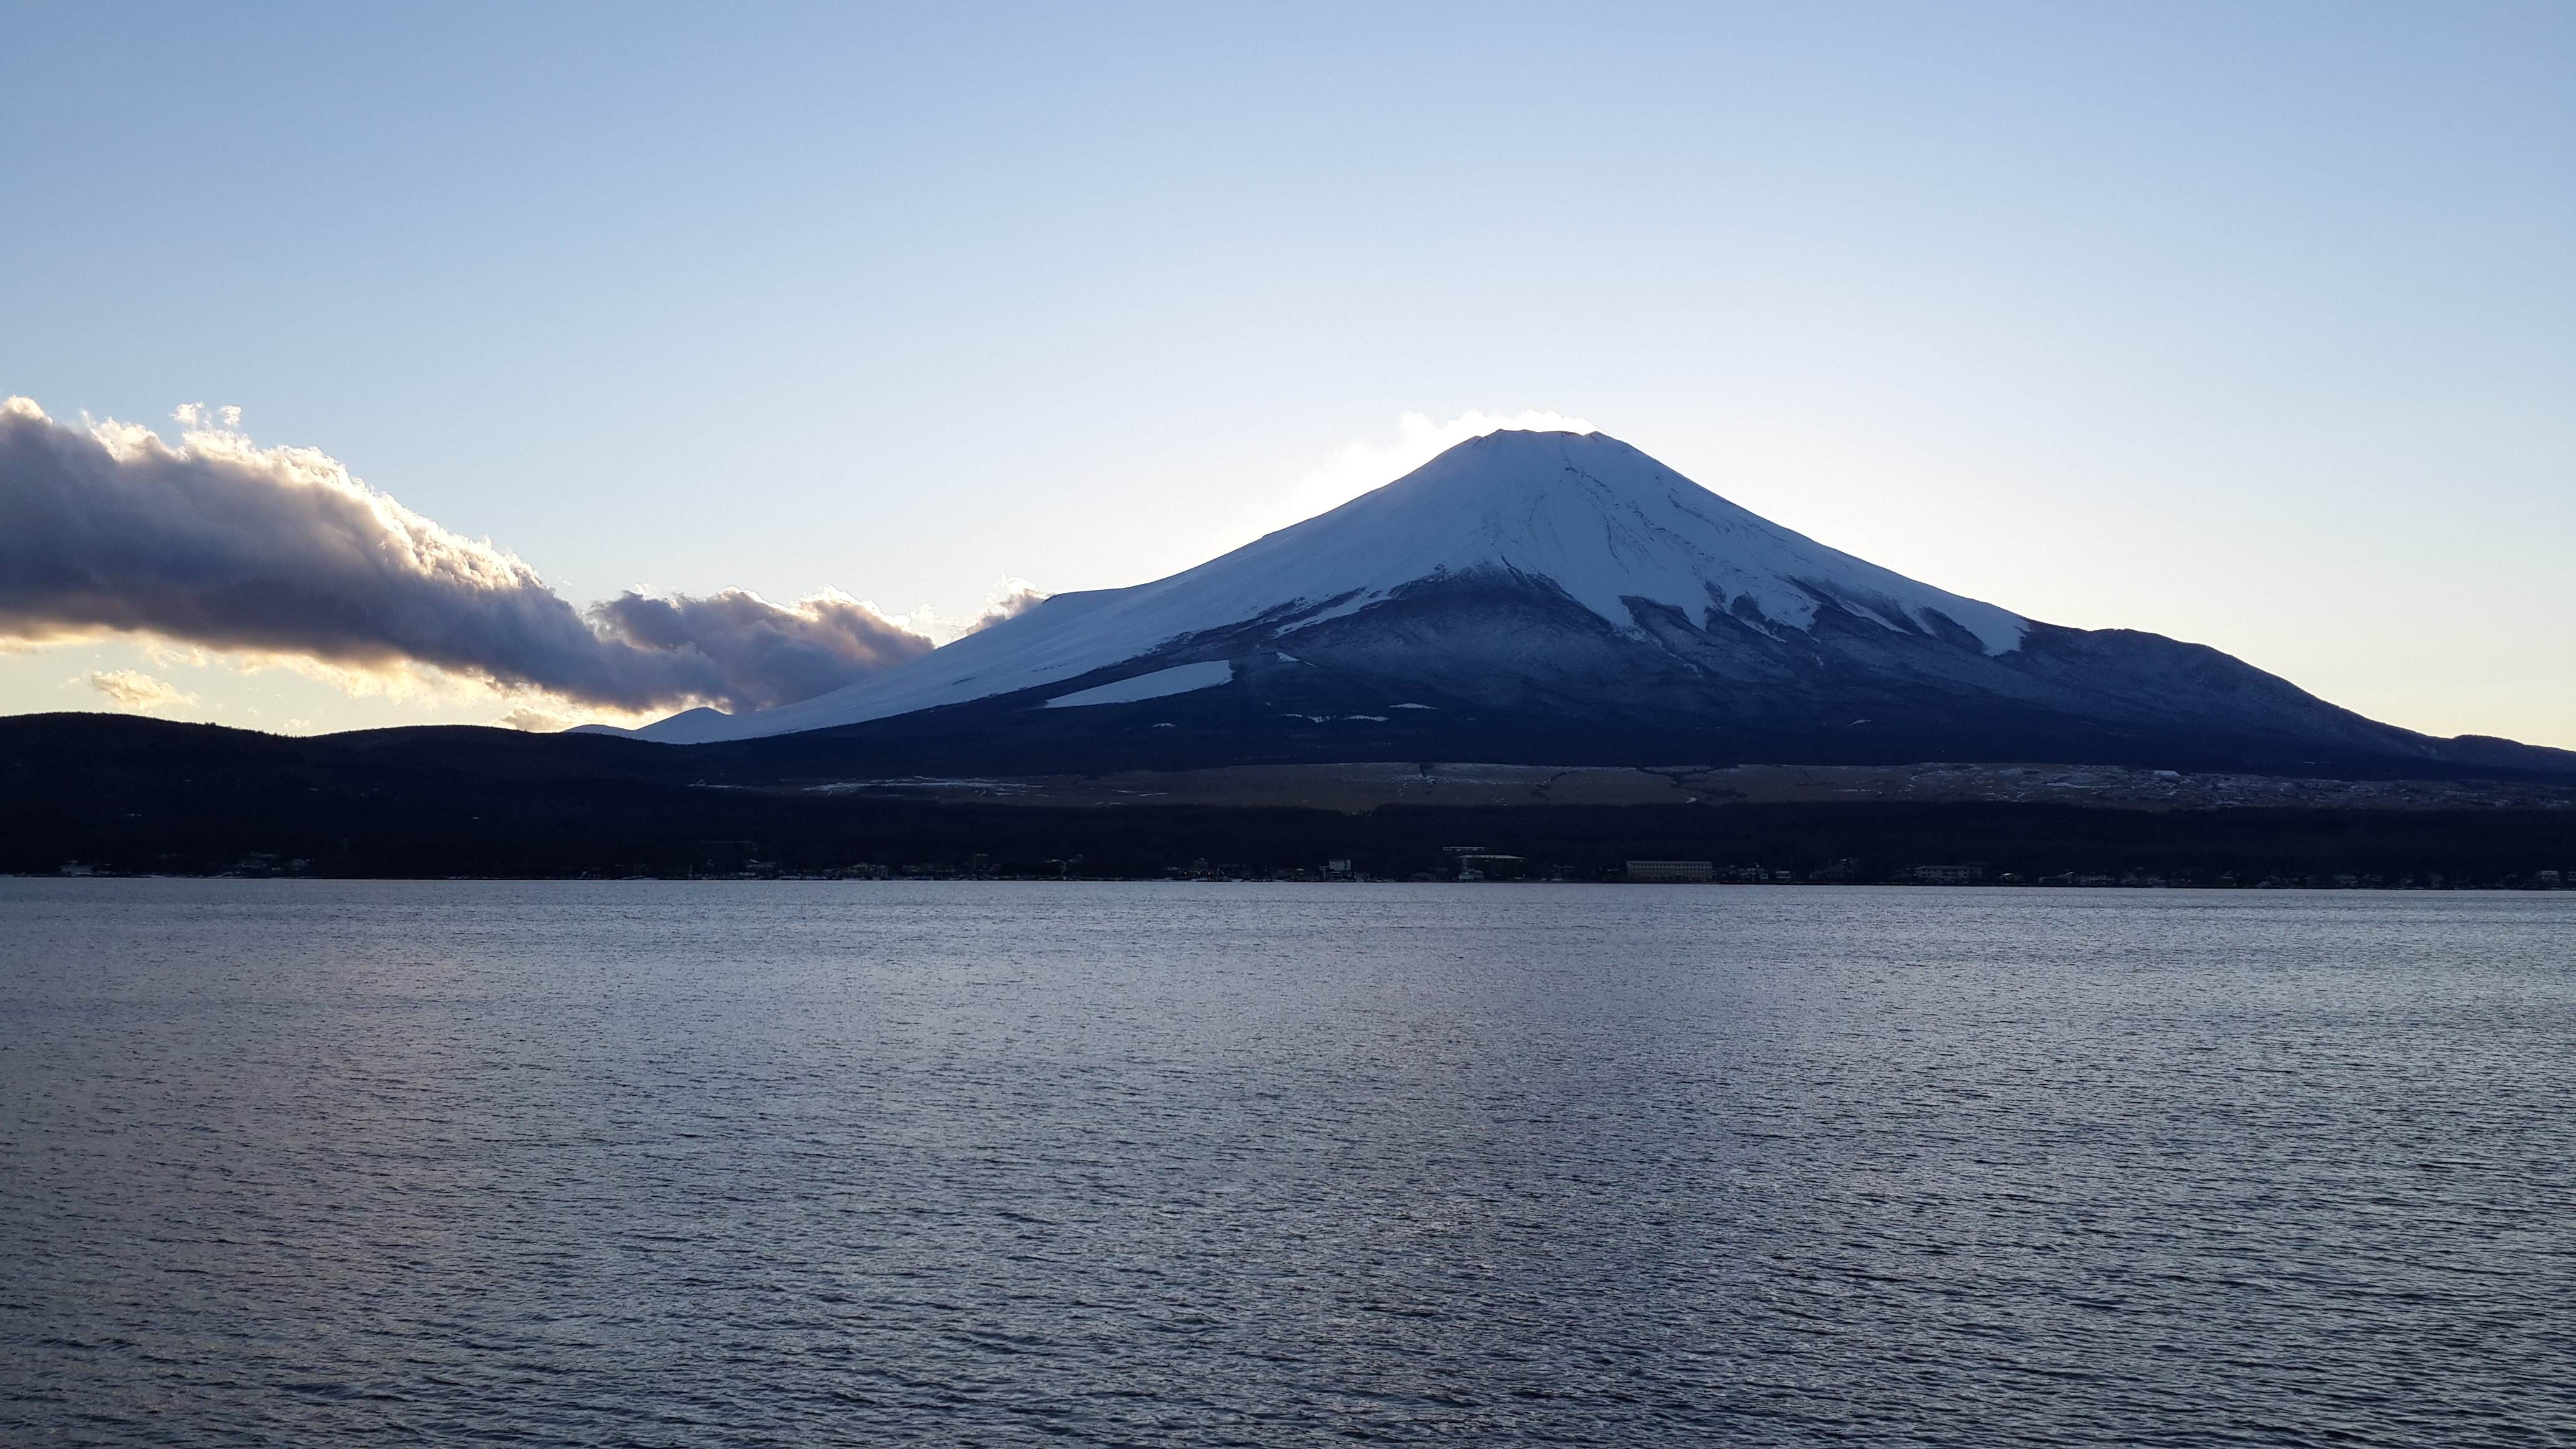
[0,882,2576,1444]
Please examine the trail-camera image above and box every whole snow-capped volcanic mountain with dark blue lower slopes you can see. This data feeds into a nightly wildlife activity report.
[603,431,2576,774]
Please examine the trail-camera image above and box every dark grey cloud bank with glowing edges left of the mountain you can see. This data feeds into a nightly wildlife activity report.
[0,397,1025,709]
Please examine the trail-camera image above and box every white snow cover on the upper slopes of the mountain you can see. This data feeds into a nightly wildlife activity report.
[642,431,2030,743]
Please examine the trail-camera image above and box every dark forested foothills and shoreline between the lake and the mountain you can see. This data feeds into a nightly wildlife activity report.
[0,714,2576,887]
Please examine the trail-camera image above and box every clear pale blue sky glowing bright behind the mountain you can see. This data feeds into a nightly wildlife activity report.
[0,2,2576,745]
